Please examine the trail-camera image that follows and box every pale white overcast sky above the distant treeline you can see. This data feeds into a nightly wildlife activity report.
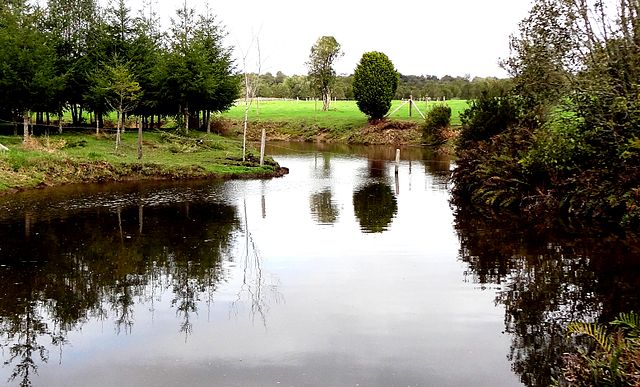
[146,0,531,77]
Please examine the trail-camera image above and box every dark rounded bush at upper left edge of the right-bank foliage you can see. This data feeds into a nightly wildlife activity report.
[459,92,521,148]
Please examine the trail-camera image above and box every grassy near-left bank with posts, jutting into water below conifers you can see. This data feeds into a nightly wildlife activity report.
[0,132,280,193]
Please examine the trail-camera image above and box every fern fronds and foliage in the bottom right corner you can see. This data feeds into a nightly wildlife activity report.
[563,312,640,386]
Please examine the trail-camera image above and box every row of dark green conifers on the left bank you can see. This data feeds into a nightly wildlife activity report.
[0,0,240,135]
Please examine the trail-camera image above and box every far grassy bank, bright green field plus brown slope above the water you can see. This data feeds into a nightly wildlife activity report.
[222,100,468,144]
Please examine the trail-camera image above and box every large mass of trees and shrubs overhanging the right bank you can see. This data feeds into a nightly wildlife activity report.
[454,0,640,227]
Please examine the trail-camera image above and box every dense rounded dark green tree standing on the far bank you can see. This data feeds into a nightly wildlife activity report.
[353,51,400,120]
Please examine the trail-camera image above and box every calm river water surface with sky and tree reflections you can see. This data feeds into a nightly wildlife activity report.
[0,144,640,386]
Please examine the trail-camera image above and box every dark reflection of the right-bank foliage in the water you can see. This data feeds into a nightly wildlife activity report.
[456,208,640,386]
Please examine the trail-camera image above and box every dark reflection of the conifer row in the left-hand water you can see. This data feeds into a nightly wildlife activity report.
[0,202,239,385]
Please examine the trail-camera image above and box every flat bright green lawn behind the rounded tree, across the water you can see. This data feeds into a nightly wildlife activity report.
[222,100,469,130]
